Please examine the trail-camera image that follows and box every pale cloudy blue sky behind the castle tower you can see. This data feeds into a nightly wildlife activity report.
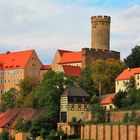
[0,0,140,64]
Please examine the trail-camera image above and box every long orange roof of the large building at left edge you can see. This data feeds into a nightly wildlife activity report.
[0,50,34,70]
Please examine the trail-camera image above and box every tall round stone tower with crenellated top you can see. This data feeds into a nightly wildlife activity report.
[91,16,111,50]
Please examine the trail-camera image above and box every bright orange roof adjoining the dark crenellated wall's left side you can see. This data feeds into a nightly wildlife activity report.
[59,52,82,64]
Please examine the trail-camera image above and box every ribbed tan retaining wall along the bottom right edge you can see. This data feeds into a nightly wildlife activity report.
[81,125,140,140]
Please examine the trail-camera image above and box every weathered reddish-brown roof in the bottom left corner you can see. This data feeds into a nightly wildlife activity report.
[0,108,40,128]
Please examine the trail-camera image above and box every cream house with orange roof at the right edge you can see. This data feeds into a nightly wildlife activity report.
[115,68,140,93]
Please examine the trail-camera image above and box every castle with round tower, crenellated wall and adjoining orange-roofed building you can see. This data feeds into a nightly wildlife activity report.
[51,16,120,71]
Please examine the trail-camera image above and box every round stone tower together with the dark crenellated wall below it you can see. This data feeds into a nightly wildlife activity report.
[82,16,120,68]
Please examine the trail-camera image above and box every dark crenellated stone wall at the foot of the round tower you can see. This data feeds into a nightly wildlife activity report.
[82,48,120,68]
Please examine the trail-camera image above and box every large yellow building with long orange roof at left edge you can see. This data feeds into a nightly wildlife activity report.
[0,50,42,94]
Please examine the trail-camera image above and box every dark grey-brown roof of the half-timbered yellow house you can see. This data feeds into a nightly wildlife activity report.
[61,86,89,97]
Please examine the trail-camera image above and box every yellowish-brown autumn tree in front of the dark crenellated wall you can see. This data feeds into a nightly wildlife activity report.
[92,59,126,94]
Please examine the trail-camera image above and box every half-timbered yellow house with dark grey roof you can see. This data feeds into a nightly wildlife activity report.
[60,87,91,122]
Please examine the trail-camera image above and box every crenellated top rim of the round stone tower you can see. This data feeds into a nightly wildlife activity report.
[91,16,111,23]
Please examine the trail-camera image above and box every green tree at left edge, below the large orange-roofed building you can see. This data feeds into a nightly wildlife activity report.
[0,88,17,112]
